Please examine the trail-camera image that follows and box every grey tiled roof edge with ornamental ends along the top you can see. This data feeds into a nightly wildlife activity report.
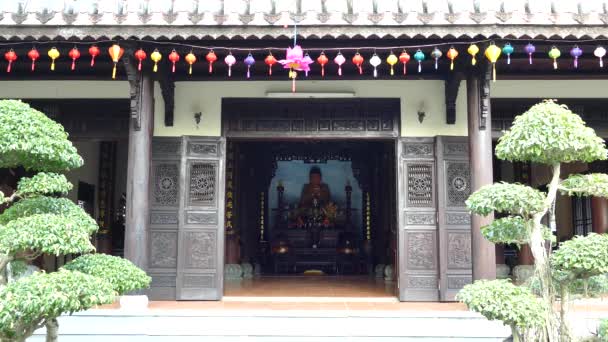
[0,0,608,38]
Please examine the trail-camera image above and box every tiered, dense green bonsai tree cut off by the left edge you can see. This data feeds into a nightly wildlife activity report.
[0,100,150,341]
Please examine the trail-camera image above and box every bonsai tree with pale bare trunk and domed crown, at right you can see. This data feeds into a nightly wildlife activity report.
[461,100,608,341]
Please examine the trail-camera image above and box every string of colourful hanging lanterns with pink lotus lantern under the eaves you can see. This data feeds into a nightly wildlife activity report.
[4,42,606,82]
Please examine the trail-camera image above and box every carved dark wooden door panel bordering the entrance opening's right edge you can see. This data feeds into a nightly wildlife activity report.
[397,138,439,301]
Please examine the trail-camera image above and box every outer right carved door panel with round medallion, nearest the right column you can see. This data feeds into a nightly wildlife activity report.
[436,137,472,301]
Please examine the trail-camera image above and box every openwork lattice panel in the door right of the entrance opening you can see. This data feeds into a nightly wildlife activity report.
[407,164,433,207]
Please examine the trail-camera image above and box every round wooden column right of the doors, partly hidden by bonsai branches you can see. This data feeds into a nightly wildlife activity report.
[467,69,496,280]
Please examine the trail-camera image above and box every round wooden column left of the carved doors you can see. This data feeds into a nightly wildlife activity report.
[125,70,154,270]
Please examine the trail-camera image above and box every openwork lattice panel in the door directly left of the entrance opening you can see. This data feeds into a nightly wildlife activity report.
[189,163,217,205]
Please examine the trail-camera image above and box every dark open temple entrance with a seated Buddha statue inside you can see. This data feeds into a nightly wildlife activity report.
[224,139,397,297]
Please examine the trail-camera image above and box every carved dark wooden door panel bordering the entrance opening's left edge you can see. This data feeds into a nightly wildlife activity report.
[177,137,226,300]
